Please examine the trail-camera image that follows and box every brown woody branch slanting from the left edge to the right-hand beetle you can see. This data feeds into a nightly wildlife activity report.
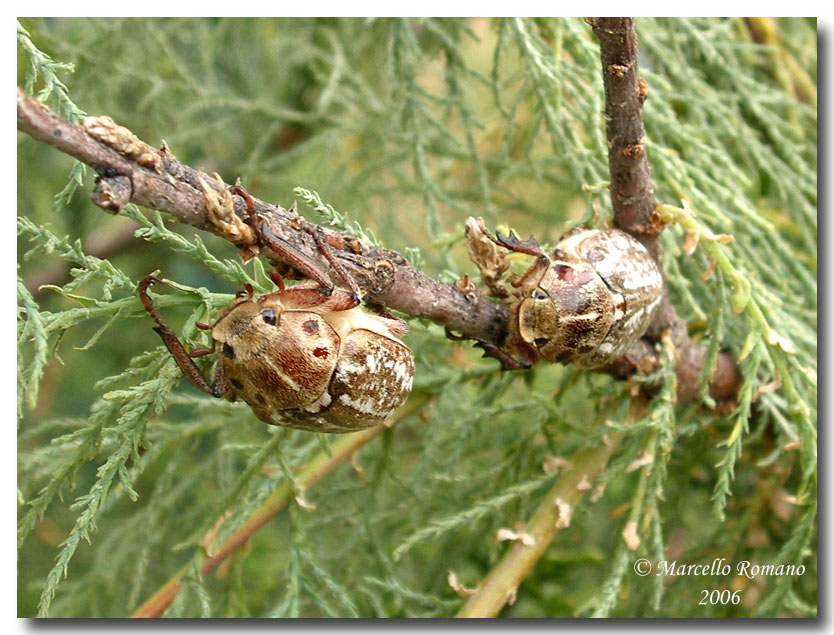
[17,89,509,344]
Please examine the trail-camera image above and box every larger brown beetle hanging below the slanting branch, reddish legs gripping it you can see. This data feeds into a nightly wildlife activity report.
[139,272,414,433]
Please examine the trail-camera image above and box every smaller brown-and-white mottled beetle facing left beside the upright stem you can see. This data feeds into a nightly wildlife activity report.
[467,219,663,369]
